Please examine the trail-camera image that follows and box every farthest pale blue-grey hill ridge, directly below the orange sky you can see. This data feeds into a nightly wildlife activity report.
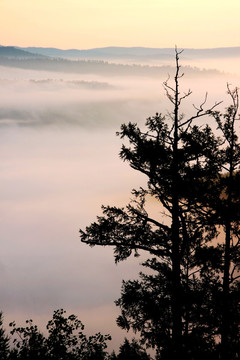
[15,47,240,61]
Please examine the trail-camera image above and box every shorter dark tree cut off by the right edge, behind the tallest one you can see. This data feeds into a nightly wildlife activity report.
[206,84,240,360]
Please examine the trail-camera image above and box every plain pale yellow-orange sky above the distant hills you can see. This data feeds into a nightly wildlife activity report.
[0,0,240,49]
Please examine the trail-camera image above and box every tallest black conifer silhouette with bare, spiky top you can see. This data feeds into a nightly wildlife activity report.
[80,49,222,359]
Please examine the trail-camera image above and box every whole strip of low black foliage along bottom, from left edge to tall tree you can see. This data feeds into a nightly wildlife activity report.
[0,309,151,360]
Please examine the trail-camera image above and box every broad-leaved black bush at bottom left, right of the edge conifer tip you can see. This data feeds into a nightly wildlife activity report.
[10,309,111,360]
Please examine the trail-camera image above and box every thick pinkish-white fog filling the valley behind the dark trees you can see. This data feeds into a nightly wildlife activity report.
[0,59,239,350]
